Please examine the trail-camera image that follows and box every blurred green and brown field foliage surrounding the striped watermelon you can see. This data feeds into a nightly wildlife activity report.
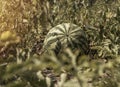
[0,0,120,87]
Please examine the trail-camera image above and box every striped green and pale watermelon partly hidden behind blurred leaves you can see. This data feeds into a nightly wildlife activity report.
[43,23,88,52]
